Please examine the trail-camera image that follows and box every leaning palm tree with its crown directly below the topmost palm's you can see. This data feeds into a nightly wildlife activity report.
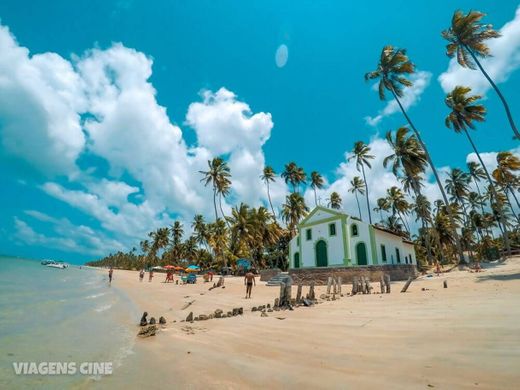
[445,86,511,256]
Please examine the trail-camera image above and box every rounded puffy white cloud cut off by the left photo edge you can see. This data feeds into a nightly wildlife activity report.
[0,25,85,175]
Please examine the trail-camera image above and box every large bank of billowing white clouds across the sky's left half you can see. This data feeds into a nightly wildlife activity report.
[0,21,285,256]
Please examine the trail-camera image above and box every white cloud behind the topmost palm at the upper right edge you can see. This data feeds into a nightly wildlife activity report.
[438,7,520,95]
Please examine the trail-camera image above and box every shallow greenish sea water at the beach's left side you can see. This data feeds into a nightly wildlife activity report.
[0,257,138,389]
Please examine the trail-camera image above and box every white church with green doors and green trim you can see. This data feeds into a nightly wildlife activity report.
[289,206,417,269]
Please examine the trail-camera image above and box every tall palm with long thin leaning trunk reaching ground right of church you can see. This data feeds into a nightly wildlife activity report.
[365,45,464,262]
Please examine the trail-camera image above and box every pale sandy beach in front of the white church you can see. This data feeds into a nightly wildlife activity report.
[101,258,520,389]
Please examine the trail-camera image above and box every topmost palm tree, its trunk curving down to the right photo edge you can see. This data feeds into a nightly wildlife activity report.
[442,10,520,139]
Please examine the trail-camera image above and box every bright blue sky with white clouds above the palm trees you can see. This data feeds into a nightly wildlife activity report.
[0,0,520,261]
